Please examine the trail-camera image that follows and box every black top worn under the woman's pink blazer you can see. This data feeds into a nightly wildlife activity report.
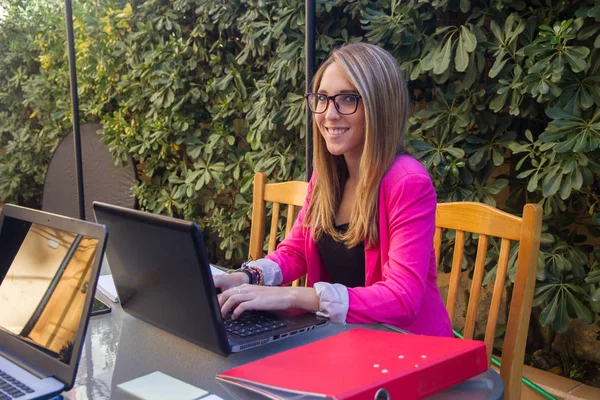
[317,224,365,287]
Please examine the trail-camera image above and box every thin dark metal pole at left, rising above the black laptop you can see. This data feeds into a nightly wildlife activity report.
[65,0,85,220]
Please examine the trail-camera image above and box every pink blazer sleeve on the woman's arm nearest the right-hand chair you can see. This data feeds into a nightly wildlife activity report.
[346,173,436,326]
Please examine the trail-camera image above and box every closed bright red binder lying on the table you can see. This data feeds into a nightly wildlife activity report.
[217,329,488,400]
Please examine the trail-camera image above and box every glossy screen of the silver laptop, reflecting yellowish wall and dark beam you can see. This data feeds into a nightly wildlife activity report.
[0,216,98,364]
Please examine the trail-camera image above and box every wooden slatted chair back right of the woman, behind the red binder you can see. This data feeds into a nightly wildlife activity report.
[434,202,542,400]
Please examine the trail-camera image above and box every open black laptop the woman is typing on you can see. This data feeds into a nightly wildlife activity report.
[93,202,327,355]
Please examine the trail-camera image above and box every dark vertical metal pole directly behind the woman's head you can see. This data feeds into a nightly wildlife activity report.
[304,0,315,181]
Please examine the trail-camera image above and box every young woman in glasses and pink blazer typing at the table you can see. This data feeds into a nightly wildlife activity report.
[214,43,452,336]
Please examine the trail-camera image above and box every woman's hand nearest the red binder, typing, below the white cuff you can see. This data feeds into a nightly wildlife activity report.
[219,284,319,319]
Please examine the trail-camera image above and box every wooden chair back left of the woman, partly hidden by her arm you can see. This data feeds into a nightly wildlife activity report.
[249,172,308,286]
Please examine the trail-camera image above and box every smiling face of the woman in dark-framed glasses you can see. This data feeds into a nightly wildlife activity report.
[314,62,365,163]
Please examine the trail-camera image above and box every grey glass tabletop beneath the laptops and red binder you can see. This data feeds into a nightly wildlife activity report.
[63,304,504,400]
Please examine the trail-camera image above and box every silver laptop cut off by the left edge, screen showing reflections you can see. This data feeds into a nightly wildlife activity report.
[0,204,107,400]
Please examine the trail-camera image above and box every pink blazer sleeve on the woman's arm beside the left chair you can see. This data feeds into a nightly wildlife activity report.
[265,177,316,285]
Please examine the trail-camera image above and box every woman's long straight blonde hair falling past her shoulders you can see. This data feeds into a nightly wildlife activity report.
[305,42,410,247]
